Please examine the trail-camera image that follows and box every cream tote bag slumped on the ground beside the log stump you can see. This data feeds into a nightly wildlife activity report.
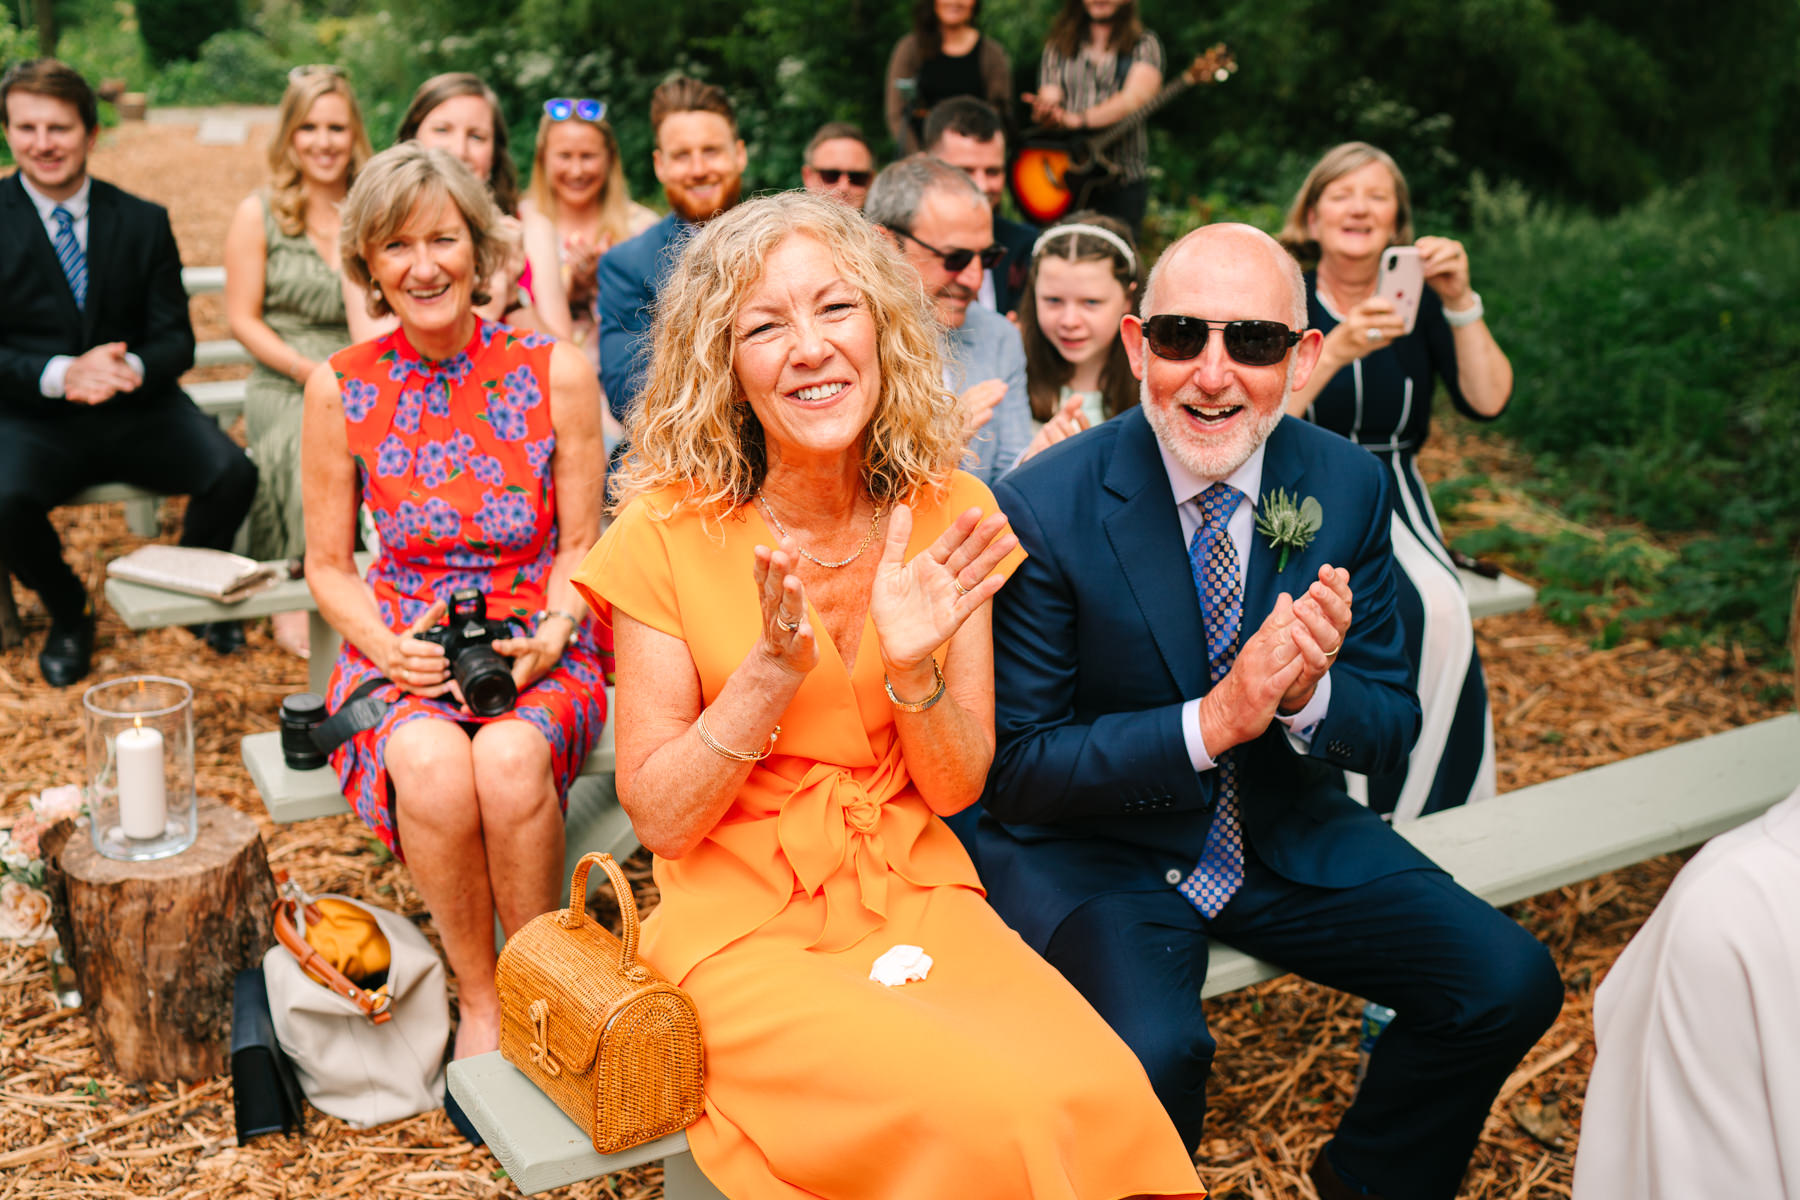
[263,896,450,1128]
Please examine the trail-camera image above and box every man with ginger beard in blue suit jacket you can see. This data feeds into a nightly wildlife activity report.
[598,76,749,421]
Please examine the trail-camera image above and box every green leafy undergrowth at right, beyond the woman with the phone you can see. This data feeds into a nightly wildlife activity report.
[1471,180,1800,653]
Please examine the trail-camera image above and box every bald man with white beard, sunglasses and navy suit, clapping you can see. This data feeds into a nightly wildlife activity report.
[976,225,1562,1200]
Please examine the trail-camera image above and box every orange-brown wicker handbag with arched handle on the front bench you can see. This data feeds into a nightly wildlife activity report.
[495,855,702,1153]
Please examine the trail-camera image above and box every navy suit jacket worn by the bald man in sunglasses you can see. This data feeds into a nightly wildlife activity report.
[976,408,1431,952]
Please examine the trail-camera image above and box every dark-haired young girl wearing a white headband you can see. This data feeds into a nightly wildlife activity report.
[1019,212,1141,457]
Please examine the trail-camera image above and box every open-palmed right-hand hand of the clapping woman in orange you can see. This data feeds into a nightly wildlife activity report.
[869,504,1019,676]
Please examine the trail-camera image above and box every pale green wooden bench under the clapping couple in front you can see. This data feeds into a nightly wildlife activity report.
[448,716,1800,1200]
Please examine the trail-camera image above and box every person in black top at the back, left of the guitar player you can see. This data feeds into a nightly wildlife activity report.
[886,0,1012,157]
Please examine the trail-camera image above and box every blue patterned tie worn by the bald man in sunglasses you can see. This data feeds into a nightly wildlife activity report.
[1181,484,1244,921]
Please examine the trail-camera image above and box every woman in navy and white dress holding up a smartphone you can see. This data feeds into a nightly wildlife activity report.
[1280,142,1512,820]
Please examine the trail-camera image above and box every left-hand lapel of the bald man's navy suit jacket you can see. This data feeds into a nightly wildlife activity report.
[1102,408,1208,698]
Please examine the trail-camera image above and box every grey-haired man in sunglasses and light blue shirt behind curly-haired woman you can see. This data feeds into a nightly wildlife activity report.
[862,155,1031,486]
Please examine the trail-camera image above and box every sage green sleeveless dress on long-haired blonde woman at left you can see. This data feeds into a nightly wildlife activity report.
[243,194,349,560]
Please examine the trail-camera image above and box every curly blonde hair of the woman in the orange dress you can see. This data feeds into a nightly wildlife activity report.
[614,193,963,511]
